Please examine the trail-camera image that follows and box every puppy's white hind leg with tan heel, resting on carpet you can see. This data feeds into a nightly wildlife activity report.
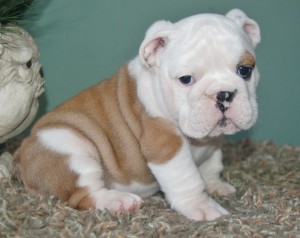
[38,128,142,213]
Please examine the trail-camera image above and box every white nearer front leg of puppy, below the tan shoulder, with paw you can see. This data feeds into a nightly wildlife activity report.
[148,139,228,220]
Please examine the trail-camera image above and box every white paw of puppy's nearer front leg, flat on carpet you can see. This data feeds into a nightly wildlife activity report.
[176,197,229,221]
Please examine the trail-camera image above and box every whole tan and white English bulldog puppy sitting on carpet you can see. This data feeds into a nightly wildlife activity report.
[14,9,260,221]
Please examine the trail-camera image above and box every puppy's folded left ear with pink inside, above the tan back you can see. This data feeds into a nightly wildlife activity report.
[139,21,173,68]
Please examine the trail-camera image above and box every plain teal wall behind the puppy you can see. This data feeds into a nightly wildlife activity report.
[24,0,300,145]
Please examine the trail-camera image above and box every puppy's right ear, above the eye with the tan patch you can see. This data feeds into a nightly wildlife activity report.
[226,9,260,47]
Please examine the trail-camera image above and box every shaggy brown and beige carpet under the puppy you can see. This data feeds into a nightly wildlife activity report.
[0,139,300,238]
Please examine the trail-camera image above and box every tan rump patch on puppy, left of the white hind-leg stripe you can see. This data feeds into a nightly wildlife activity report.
[13,136,78,201]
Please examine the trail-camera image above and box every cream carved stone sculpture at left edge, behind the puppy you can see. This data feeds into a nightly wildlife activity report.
[0,26,44,178]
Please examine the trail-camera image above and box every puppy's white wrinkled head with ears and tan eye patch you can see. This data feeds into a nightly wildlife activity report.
[139,9,260,138]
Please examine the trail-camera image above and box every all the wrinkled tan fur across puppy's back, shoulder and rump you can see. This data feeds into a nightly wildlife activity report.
[15,65,182,207]
